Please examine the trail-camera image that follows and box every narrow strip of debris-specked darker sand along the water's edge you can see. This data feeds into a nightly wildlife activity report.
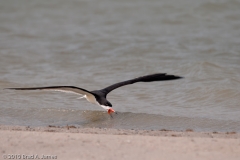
[0,125,240,139]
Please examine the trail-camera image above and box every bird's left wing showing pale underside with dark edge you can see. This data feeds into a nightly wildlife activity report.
[6,86,93,95]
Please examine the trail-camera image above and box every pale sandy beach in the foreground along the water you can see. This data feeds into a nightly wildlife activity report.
[0,126,240,160]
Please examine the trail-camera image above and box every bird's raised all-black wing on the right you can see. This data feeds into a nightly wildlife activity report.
[102,73,183,95]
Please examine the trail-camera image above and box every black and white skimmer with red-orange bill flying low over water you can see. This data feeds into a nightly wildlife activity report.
[6,73,182,115]
